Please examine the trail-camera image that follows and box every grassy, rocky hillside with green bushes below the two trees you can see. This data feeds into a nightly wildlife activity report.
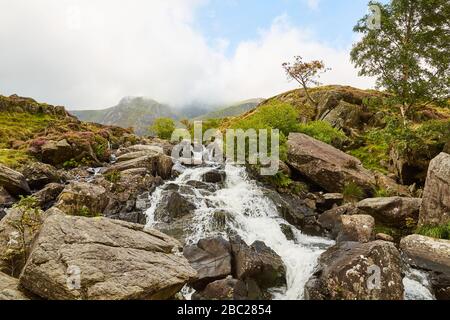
[222,86,450,186]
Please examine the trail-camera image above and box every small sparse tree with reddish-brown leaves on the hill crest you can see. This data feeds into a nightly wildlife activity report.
[283,56,329,107]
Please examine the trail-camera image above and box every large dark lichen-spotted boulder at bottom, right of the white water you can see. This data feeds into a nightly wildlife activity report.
[305,241,404,300]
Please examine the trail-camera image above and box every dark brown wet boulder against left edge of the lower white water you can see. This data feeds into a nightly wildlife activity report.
[230,236,286,289]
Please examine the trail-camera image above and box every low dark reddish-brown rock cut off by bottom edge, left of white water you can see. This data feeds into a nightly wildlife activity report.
[192,277,263,300]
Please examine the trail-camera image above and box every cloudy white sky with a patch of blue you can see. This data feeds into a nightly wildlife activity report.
[0,0,382,110]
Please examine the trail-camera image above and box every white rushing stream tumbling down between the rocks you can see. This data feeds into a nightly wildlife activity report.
[146,160,432,300]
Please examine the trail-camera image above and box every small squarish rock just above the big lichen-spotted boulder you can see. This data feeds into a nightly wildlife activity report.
[337,214,375,243]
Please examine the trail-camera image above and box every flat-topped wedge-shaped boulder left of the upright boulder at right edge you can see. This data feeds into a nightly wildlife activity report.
[356,197,422,228]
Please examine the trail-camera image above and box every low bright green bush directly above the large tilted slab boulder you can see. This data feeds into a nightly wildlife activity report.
[297,121,347,146]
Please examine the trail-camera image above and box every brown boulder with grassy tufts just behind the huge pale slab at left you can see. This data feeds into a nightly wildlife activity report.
[55,181,109,217]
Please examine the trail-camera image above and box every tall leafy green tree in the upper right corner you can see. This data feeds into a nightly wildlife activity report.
[351,0,450,123]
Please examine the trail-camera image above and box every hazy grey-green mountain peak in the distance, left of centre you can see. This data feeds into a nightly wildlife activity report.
[71,97,180,135]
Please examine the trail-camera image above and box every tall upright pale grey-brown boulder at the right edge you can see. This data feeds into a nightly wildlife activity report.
[419,152,450,225]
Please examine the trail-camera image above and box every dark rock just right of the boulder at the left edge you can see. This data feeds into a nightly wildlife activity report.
[21,162,62,190]
